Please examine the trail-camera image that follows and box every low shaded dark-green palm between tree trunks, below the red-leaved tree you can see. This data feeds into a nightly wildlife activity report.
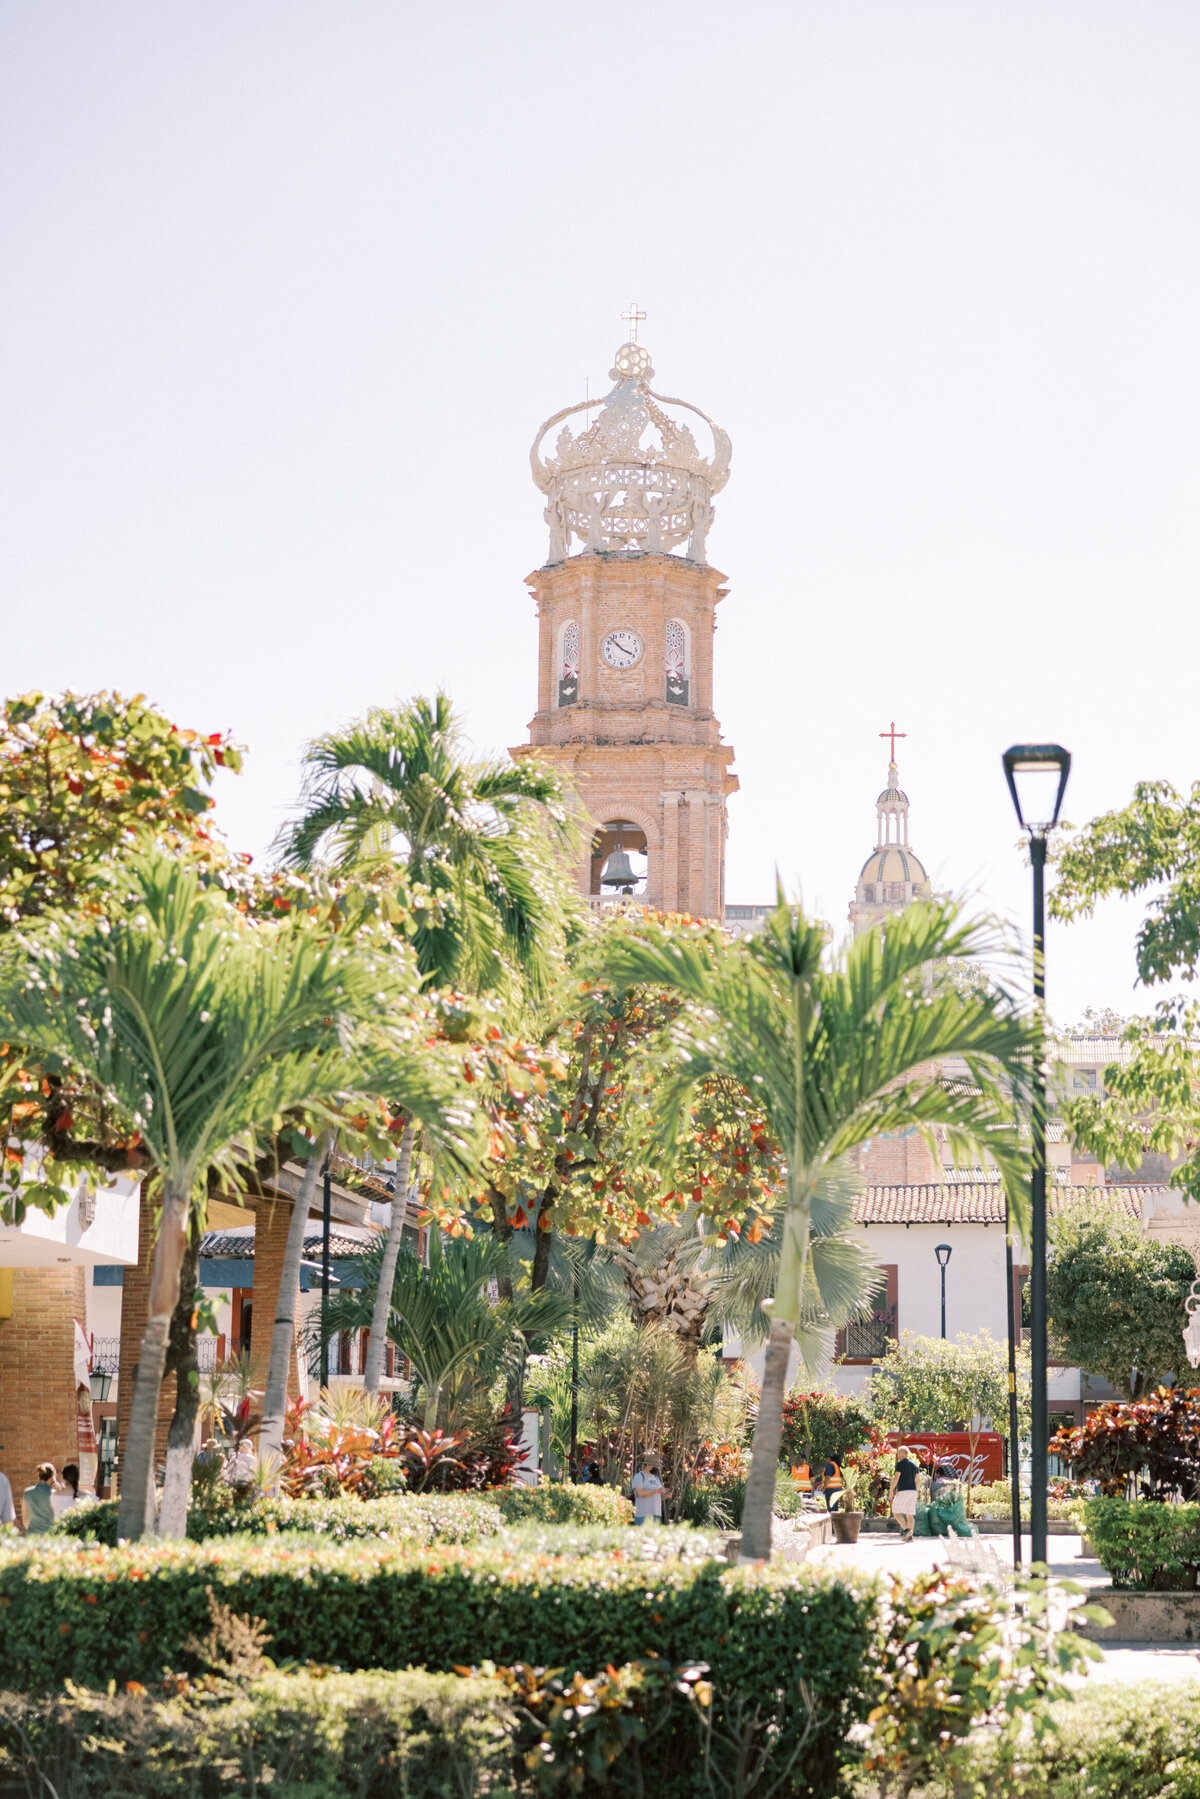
[318,1231,570,1430]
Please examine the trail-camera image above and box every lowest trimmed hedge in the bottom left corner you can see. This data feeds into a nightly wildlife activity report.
[0,1671,516,1799]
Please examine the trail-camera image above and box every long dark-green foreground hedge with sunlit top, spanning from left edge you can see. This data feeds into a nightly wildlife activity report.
[0,1538,876,1794]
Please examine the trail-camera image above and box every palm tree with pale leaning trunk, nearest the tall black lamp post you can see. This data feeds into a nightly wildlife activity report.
[608,891,1036,1560]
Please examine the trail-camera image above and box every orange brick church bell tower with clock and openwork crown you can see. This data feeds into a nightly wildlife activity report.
[513,327,738,919]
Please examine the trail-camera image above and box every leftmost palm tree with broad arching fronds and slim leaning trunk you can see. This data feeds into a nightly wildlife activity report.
[0,853,467,1538]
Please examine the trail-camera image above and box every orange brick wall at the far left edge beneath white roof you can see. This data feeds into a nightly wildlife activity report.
[0,1265,86,1508]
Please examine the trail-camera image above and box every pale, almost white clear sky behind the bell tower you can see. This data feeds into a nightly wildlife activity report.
[0,0,1200,1024]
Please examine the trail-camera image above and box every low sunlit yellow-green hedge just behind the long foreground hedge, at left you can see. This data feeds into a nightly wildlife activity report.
[54,1493,502,1549]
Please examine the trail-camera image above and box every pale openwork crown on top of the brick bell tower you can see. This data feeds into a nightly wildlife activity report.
[529,344,732,563]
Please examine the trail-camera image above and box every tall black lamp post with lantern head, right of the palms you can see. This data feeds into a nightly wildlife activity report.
[1004,743,1070,1563]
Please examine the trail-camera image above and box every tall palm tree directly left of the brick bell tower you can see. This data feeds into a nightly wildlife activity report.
[279,693,569,1392]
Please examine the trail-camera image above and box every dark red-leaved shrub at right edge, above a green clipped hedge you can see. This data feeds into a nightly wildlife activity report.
[1051,1387,1200,1500]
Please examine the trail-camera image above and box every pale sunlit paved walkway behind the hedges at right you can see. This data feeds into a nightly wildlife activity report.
[808,1531,1200,1680]
